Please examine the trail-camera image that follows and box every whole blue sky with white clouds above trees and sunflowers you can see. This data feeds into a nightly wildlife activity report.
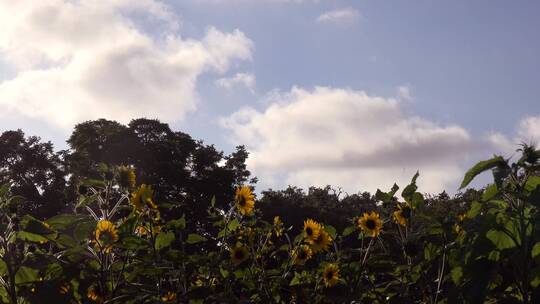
[0,0,540,193]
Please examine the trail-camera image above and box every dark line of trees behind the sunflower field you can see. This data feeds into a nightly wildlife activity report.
[0,118,477,231]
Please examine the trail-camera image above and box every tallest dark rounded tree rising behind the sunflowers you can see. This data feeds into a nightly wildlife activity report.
[66,118,255,220]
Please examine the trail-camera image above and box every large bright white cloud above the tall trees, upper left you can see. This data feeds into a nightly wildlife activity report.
[0,0,252,128]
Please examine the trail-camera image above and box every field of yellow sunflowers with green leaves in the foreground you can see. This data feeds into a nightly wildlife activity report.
[0,146,540,303]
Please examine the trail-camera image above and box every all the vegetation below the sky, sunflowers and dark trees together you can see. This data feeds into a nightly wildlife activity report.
[0,119,540,303]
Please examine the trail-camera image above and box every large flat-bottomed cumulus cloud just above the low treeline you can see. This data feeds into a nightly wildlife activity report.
[222,87,476,192]
